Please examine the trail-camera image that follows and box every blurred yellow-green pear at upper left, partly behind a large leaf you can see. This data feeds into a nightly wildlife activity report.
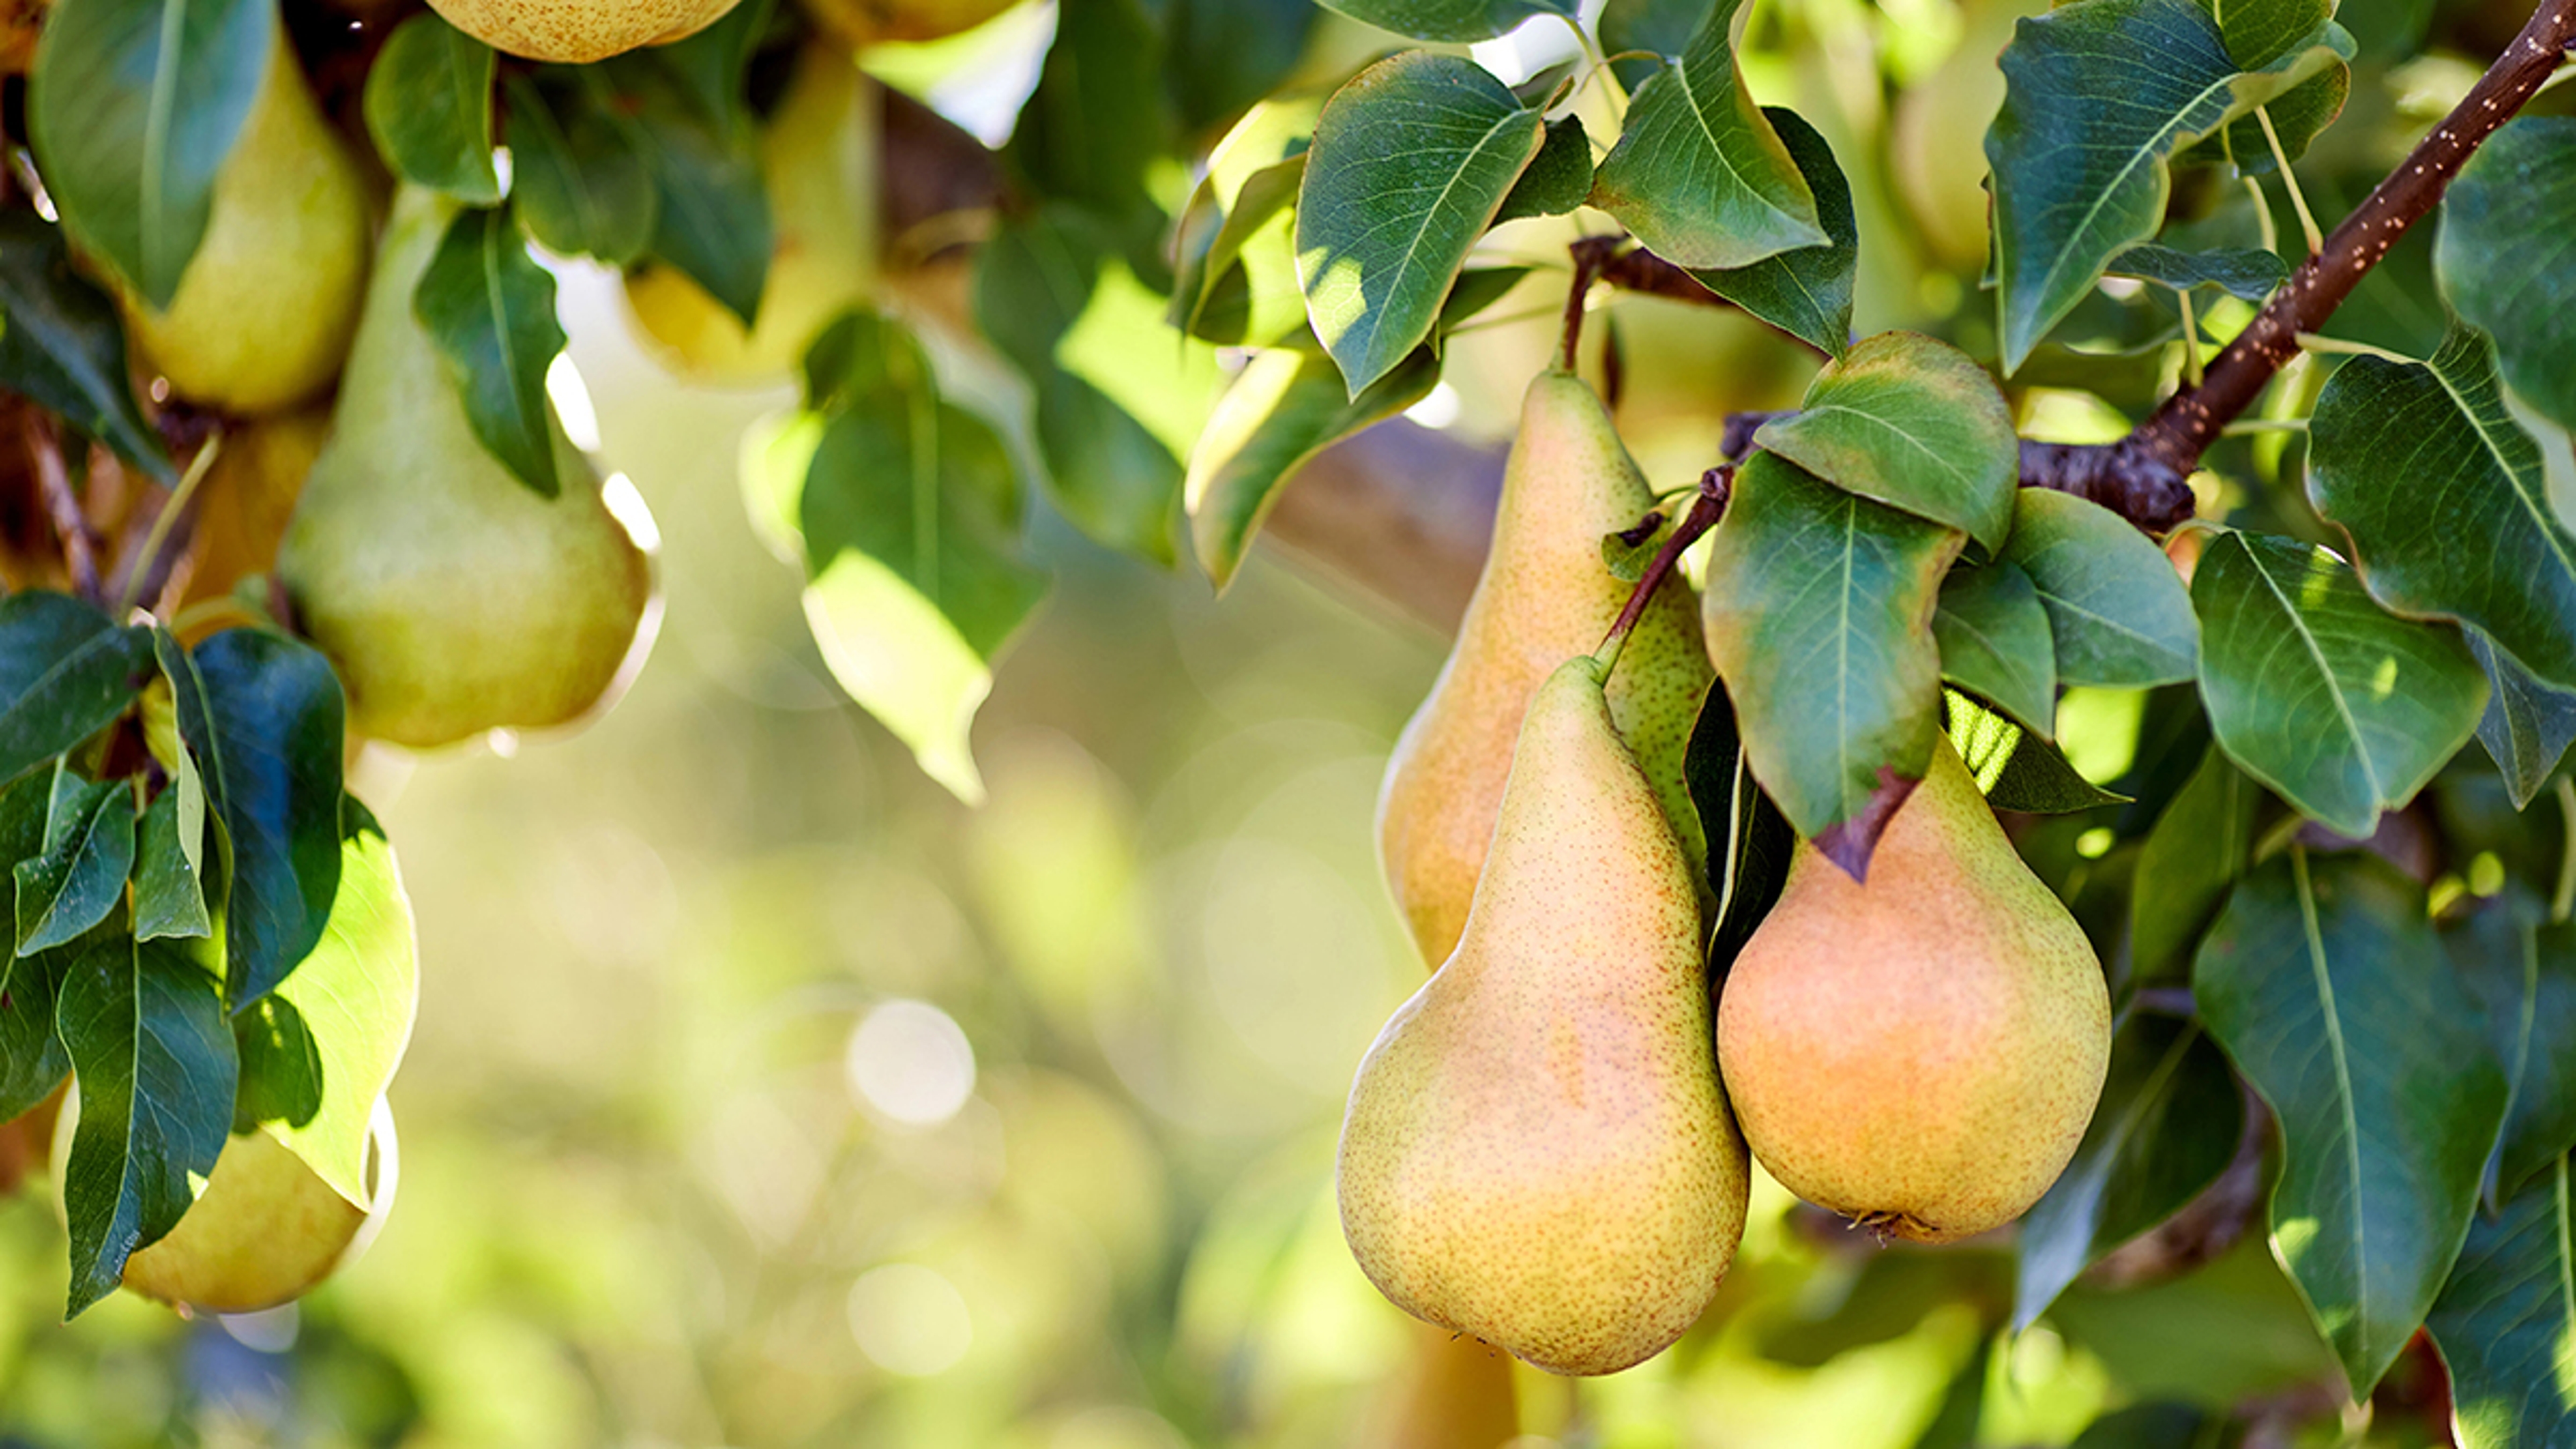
[116,34,368,413]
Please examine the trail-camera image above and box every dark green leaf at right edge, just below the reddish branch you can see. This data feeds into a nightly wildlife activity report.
[2308,327,2576,688]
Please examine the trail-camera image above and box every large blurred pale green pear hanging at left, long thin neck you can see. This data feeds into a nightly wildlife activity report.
[278,186,652,748]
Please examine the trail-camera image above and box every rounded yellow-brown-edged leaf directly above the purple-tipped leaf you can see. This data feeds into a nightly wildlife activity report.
[1754,333,2019,549]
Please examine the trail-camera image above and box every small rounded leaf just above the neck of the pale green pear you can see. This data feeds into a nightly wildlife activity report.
[366,13,499,206]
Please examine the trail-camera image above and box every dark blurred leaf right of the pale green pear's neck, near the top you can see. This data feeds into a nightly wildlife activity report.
[505,70,659,266]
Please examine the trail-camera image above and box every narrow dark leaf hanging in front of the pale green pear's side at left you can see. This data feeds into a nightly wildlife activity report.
[412,206,564,498]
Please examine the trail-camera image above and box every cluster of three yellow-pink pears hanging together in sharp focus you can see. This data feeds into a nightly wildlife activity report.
[1340,371,2110,1375]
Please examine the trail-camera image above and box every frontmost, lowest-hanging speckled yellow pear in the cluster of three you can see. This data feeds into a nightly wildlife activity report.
[1340,655,1749,1375]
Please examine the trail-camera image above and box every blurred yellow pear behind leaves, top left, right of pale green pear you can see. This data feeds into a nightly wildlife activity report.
[626,46,876,379]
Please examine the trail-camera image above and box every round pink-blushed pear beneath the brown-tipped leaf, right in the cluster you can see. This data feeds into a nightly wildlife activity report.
[1718,740,2110,1243]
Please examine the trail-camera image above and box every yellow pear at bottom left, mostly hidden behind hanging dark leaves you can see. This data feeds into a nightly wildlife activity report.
[54,1088,402,1312]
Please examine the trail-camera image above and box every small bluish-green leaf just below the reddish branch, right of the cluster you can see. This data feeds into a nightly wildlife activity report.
[2004,487,2200,688]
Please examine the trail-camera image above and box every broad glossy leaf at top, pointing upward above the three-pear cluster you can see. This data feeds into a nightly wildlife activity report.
[1592,0,1831,268]
